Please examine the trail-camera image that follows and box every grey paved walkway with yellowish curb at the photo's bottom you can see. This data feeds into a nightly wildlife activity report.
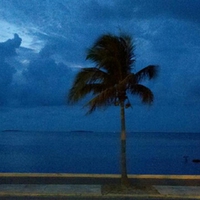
[0,184,200,199]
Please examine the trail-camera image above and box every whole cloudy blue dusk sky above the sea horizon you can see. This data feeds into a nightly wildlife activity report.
[0,0,200,132]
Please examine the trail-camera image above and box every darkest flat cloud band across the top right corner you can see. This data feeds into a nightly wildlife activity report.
[110,0,200,22]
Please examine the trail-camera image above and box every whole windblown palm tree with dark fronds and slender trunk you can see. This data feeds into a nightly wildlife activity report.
[68,34,157,185]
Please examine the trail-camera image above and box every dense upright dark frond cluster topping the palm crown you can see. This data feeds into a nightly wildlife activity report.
[86,34,135,79]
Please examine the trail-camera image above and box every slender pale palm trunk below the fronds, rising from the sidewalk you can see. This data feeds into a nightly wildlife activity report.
[120,102,129,185]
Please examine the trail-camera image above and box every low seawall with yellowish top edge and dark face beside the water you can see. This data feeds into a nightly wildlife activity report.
[0,173,200,186]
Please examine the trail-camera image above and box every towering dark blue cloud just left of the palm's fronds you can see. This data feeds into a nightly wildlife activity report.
[20,45,72,106]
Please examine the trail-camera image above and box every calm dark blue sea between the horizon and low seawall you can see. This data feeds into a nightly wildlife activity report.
[0,131,200,175]
